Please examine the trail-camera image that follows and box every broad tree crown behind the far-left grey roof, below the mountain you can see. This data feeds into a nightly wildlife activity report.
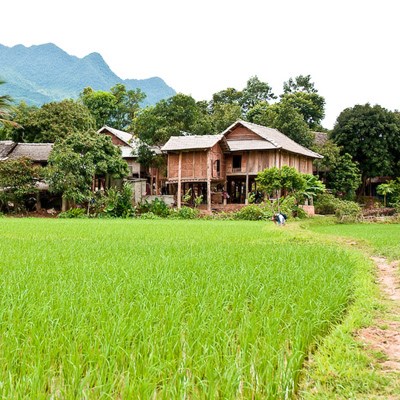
[11,100,95,143]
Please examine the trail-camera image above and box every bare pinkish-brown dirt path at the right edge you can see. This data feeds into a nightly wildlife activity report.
[358,257,400,372]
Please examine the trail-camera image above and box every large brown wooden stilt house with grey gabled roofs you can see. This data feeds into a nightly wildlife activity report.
[161,121,322,211]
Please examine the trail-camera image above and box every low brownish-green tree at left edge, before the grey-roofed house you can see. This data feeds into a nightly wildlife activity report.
[0,158,40,211]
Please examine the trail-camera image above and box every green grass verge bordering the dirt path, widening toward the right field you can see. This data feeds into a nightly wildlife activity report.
[300,221,400,400]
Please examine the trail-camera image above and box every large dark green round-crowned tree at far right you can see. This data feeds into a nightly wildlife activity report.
[331,104,400,192]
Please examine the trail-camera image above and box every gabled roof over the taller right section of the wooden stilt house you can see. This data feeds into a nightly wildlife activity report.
[222,120,323,158]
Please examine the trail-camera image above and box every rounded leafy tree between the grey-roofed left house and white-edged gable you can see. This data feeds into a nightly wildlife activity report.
[47,131,128,208]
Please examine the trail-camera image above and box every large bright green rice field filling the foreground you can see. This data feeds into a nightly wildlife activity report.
[0,218,368,399]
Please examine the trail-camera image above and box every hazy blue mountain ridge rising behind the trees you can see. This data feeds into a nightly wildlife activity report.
[0,43,176,106]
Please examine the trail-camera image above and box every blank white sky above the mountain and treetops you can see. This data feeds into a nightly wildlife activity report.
[0,0,400,129]
